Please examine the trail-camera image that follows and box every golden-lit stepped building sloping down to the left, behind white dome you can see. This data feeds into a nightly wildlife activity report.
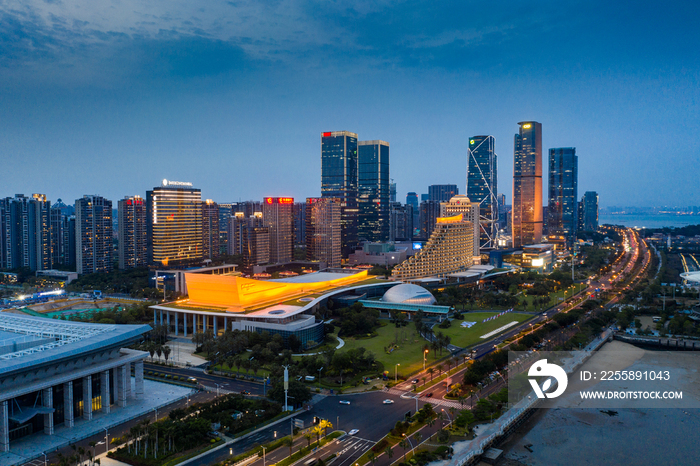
[391,214,478,280]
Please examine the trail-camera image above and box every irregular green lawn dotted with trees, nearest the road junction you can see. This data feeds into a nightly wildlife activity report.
[338,323,446,379]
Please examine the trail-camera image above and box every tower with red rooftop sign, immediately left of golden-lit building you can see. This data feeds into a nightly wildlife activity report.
[117,196,148,270]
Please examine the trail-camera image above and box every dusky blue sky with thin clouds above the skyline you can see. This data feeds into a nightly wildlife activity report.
[0,0,700,206]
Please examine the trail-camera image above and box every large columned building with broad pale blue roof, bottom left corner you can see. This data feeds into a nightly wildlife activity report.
[0,313,151,456]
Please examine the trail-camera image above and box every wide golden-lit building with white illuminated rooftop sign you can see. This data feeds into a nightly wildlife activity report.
[146,180,203,267]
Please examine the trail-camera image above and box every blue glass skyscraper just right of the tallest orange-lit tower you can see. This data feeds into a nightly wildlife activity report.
[547,147,578,246]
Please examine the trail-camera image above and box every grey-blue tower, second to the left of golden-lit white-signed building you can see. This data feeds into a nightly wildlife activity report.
[75,195,114,274]
